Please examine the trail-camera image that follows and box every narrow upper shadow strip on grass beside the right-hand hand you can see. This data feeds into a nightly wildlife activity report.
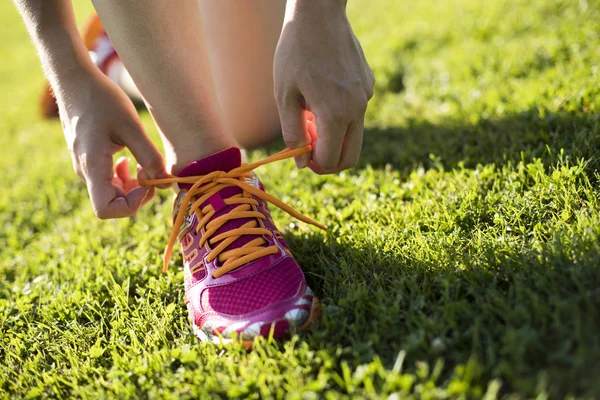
[359,107,600,170]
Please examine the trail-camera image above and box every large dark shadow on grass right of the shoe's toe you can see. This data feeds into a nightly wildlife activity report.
[286,230,600,398]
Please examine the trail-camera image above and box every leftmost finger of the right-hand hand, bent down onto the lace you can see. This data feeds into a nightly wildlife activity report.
[279,97,311,168]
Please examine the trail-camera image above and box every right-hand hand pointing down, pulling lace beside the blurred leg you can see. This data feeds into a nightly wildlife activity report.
[273,0,375,174]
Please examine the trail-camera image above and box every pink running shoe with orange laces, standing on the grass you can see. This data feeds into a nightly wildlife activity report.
[140,146,325,346]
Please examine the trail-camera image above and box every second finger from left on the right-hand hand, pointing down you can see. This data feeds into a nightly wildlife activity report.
[312,114,348,171]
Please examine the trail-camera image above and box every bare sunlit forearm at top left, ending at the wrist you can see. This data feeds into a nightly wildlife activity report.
[14,0,93,97]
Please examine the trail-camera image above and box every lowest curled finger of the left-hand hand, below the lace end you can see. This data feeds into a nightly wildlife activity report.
[82,153,149,219]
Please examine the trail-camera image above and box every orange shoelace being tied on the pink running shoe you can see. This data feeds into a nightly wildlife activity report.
[139,145,327,278]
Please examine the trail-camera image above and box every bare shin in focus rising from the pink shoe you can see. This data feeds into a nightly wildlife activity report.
[93,0,236,173]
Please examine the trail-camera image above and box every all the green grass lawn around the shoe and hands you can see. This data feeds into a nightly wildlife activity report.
[0,0,600,399]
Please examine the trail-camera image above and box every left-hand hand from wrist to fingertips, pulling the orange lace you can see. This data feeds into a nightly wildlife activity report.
[57,71,168,219]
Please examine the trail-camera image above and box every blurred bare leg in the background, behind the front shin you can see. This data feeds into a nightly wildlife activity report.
[198,0,285,147]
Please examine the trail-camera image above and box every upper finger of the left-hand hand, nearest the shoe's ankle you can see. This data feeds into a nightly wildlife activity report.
[120,124,168,179]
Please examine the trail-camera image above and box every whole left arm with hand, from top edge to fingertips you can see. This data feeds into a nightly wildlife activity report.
[14,0,167,218]
